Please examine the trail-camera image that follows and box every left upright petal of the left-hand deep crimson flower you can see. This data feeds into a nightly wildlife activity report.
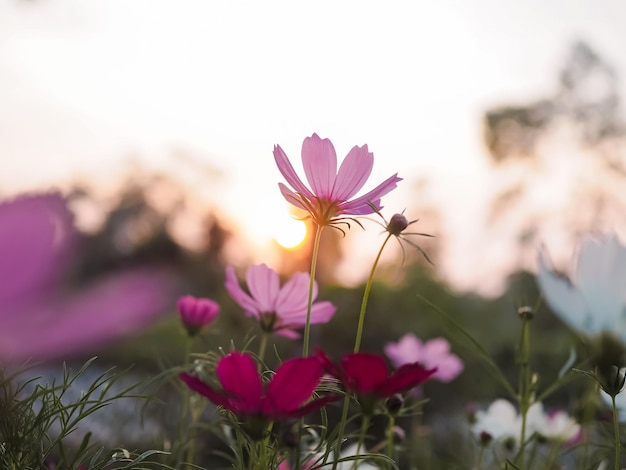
[216,351,263,412]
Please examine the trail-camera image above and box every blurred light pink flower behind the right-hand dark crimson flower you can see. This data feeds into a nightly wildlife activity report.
[385,333,463,382]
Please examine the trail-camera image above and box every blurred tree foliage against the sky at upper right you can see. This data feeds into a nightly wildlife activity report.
[484,41,626,166]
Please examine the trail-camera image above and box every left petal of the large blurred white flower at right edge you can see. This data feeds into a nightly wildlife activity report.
[537,250,588,334]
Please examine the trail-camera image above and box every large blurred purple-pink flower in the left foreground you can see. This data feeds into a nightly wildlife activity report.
[0,193,171,362]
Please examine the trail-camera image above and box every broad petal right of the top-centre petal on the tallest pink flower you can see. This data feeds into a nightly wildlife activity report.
[331,145,374,200]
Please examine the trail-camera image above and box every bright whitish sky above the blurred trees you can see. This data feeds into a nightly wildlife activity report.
[0,0,626,294]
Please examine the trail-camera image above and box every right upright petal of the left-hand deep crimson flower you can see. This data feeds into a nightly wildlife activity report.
[263,357,323,415]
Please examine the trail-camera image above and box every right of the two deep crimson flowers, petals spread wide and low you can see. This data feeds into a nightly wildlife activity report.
[317,350,436,413]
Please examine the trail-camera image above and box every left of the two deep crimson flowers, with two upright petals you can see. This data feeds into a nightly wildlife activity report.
[180,352,336,437]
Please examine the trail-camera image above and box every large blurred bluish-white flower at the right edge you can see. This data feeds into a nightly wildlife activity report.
[537,235,626,341]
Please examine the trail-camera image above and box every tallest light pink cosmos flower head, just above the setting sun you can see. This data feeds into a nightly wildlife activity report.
[274,134,402,226]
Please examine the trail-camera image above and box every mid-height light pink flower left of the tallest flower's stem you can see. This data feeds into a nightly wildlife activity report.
[225,264,336,338]
